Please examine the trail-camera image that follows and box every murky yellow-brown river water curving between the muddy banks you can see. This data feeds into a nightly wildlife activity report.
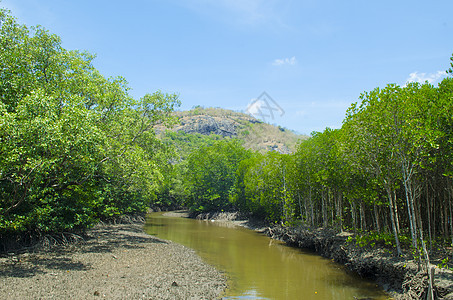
[145,213,389,299]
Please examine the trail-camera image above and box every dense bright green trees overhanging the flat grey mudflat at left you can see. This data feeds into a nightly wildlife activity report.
[0,10,179,239]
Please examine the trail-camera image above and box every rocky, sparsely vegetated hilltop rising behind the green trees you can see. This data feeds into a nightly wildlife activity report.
[157,107,307,154]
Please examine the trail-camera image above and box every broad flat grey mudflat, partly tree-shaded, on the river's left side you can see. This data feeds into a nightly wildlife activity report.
[0,220,226,299]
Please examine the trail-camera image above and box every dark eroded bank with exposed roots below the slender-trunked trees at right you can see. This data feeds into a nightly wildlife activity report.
[188,212,453,299]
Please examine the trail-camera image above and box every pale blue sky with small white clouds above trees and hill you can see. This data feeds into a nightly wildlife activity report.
[0,0,453,134]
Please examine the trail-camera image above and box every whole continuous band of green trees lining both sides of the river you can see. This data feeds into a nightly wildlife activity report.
[0,6,453,272]
